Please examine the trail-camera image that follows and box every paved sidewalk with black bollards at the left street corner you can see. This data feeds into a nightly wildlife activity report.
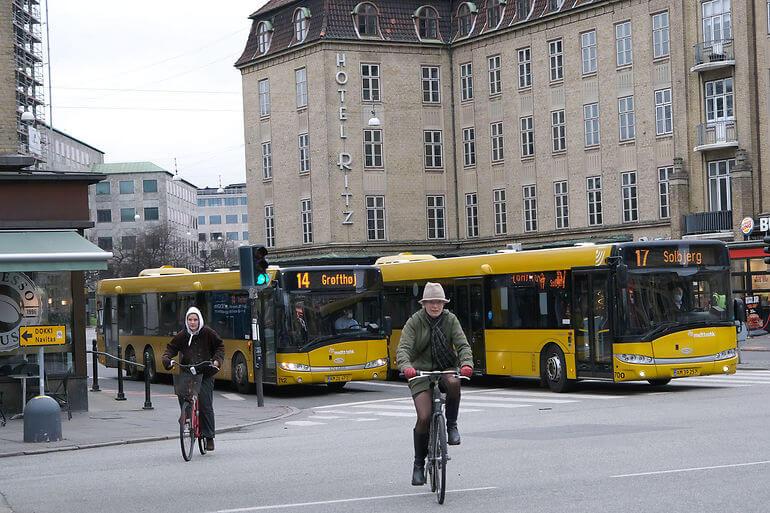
[0,379,298,458]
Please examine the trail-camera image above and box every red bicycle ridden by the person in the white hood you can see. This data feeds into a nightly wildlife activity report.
[174,361,216,461]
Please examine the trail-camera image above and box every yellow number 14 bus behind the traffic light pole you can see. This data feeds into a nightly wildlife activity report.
[97,266,388,392]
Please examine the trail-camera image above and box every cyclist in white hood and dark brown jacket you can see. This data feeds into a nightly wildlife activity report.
[163,306,225,451]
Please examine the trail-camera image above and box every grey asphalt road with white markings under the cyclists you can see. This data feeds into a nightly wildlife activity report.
[0,370,770,513]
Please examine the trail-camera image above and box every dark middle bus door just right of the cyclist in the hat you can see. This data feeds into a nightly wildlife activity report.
[448,278,486,372]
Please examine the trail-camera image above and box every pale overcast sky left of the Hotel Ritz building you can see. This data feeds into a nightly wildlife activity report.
[46,0,267,187]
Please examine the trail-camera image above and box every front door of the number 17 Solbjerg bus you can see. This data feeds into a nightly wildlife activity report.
[572,269,612,378]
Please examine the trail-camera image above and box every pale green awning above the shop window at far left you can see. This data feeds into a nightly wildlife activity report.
[0,230,112,272]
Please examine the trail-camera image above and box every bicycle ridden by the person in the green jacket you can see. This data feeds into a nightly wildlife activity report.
[409,370,469,504]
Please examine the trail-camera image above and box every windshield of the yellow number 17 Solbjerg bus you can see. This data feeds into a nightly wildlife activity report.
[617,268,732,338]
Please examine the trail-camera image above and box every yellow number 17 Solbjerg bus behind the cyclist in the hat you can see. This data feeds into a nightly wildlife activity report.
[377,240,739,392]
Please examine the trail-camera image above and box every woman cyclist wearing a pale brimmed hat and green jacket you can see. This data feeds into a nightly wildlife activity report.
[396,282,473,486]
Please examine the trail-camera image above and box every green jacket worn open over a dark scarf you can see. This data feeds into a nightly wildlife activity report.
[396,308,473,371]
